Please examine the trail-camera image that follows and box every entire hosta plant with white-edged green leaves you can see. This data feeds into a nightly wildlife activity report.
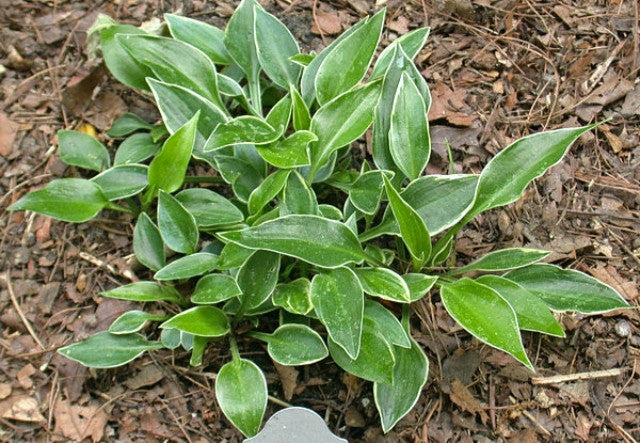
[10,0,627,436]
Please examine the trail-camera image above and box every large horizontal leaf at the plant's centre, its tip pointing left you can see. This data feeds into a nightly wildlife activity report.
[218,215,364,268]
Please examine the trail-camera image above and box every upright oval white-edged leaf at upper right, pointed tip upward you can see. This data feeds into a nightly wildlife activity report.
[389,72,431,180]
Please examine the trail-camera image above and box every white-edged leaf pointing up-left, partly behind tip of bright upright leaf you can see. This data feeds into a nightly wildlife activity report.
[149,79,227,161]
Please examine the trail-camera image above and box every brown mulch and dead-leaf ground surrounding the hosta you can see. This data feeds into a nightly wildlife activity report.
[0,0,640,442]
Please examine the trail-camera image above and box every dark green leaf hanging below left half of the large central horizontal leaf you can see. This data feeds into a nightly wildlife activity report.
[236,251,280,309]
